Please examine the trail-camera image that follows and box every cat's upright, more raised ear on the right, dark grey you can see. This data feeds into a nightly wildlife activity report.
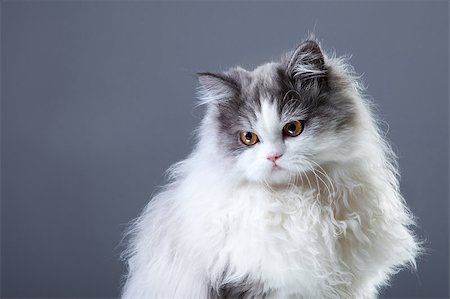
[286,40,327,88]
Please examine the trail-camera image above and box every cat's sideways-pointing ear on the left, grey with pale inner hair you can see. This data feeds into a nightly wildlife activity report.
[195,72,239,104]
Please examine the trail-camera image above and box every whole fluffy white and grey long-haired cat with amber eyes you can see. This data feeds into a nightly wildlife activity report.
[122,38,420,299]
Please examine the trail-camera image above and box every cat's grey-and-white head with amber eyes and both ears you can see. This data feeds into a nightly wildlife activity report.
[198,40,355,184]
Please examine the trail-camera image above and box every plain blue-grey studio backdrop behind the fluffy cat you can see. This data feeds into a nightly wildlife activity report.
[1,1,449,298]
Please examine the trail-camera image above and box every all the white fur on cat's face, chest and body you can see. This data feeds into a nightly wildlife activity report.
[123,51,419,299]
